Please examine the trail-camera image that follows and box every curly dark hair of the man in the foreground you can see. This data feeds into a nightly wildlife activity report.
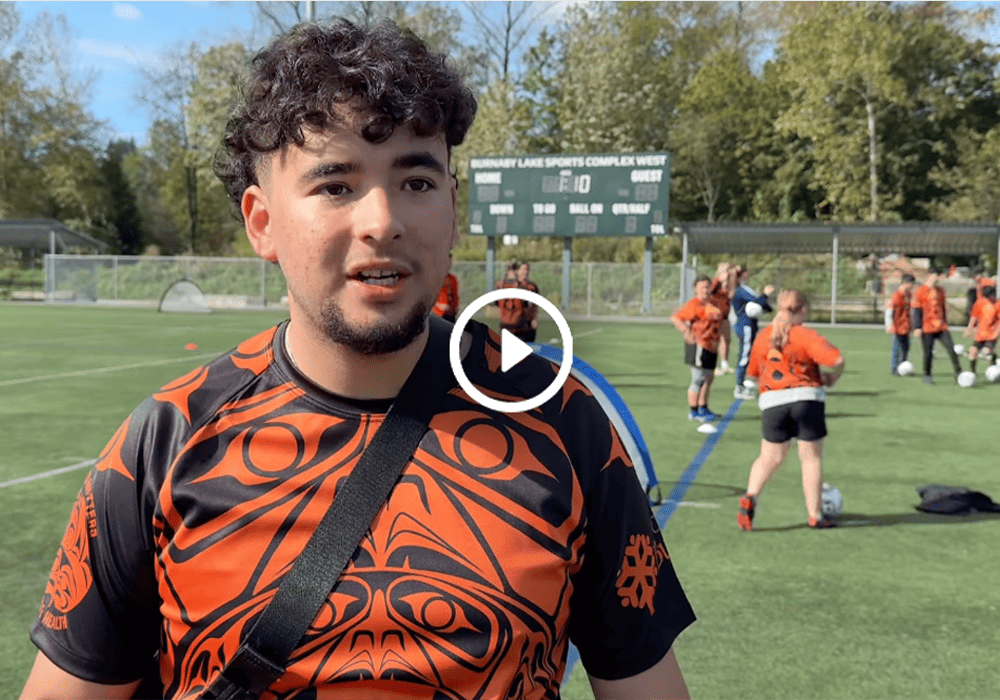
[214,19,476,219]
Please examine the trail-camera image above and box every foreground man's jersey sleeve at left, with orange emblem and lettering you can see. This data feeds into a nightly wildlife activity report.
[31,400,166,684]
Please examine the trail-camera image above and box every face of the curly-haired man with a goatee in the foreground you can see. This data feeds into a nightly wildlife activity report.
[243,122,458,354]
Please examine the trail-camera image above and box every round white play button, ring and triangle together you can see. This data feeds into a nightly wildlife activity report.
[448,287,573,413]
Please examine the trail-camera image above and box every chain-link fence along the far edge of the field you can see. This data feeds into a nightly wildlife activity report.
[45,255,916,323]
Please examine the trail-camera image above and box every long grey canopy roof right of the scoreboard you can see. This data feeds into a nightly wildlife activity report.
[674,221,1000,256]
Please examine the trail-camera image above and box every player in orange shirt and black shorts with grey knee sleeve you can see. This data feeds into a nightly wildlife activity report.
[670,275,722,423]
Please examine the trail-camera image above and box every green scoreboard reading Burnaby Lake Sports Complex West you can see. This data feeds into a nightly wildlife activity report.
[469,152,670,236]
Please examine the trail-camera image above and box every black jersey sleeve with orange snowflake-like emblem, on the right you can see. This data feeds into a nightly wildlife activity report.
[569,388,695,680]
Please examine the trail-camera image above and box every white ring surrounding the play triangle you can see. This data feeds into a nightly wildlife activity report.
[448,287,573,413]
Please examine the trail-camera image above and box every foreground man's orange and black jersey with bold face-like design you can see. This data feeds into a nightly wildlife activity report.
[32,322,694,700]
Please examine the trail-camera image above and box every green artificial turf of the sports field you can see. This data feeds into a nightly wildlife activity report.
[0,305,1000,700]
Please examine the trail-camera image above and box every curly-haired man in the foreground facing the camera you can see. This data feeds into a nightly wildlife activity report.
[22,21,693,700]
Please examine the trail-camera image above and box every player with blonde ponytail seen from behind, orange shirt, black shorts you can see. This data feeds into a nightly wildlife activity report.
[736,289,844,530]
